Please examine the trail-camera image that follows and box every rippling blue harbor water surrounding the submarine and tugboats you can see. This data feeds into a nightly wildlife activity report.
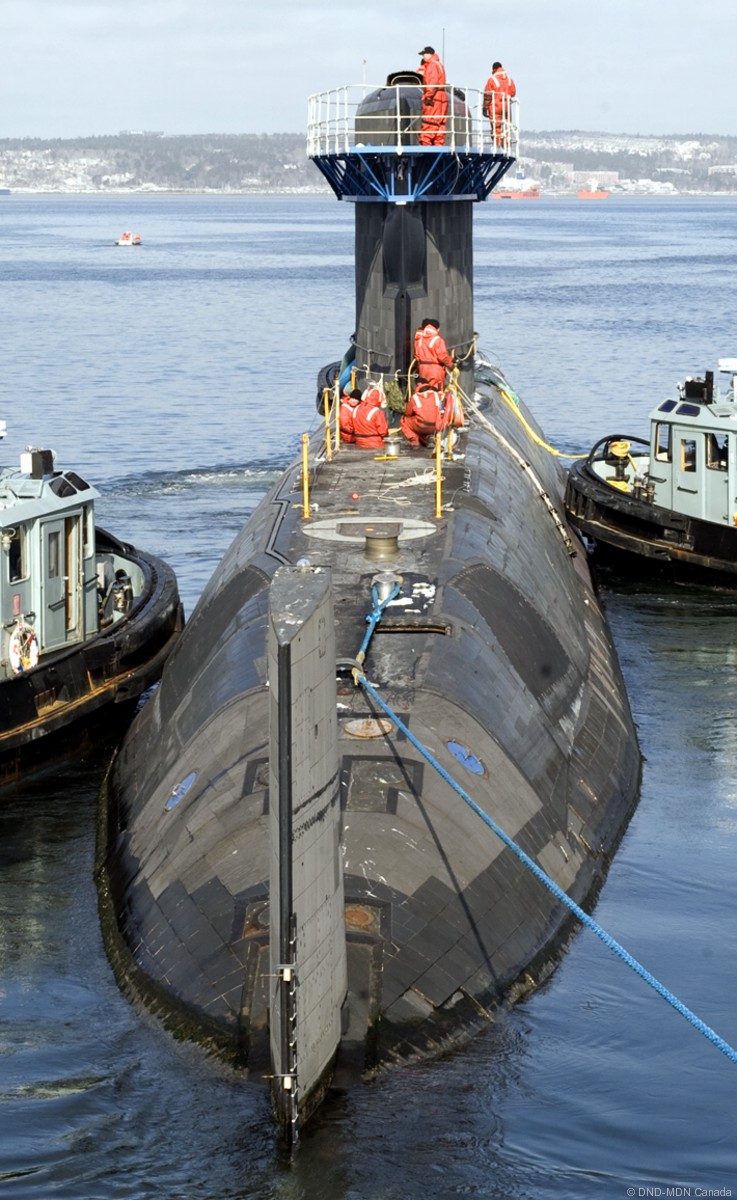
[0,194,737,1200]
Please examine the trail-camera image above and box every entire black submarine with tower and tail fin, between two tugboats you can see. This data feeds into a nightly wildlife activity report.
[96,72,641,1144]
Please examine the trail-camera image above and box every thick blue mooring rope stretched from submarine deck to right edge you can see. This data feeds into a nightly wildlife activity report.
[353,595,737,1063]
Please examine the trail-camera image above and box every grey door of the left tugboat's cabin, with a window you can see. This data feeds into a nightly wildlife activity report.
[41,514,83,650]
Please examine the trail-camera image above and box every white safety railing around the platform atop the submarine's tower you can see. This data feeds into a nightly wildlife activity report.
[307,83,520,158]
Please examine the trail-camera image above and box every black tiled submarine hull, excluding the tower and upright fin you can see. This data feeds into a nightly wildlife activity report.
[98,367,640,1081]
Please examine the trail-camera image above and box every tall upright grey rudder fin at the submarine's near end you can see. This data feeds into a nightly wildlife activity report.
[268,566,347,1142]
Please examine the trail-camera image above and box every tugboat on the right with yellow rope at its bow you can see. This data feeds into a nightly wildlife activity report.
[565,359,737,588]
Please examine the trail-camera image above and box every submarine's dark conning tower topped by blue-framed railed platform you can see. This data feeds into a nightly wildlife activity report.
[307,71,519,390]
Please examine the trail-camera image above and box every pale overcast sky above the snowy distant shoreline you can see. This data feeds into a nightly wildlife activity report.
[5,0,737,138]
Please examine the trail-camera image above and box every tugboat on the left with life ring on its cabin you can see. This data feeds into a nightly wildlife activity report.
[0,422,184,782]
